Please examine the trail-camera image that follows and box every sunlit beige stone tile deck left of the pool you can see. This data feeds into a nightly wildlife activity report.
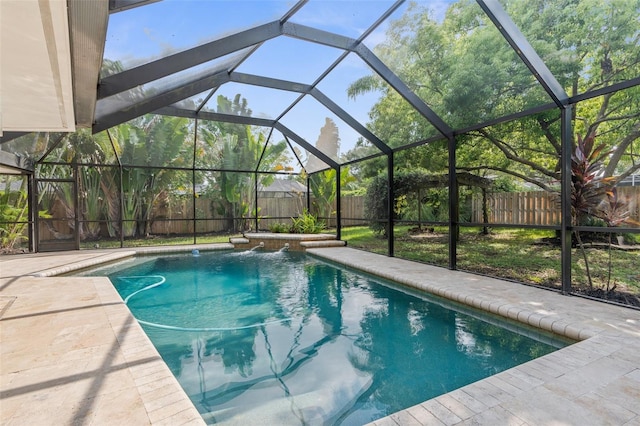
[0,245,232,426]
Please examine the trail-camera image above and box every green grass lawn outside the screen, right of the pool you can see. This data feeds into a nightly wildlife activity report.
[342,226,640,295]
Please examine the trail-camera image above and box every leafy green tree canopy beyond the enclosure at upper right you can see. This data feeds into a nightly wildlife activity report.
[347,0,640,190]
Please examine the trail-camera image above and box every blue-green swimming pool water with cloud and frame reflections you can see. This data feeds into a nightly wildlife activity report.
[81,251,566,425]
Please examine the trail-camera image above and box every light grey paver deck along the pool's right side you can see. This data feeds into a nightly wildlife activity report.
[307,248,640,426]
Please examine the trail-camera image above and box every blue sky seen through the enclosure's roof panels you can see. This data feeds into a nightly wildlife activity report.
[104,0,452,161]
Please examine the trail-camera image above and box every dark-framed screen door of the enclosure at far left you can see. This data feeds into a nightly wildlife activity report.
[36,179,80,251]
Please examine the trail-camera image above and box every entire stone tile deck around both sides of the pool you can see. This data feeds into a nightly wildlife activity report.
[0,245,640,426]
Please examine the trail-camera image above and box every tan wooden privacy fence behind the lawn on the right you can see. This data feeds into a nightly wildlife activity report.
[471,186,640,225]
